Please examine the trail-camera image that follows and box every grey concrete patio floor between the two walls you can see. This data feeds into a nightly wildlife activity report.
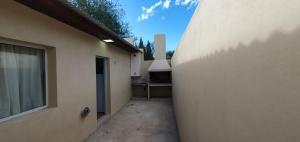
[86,99,179,142]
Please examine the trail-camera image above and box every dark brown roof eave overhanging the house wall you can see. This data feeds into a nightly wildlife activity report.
[15,0,138,52]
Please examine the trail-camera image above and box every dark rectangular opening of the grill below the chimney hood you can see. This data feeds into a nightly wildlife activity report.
[149,71,172,84]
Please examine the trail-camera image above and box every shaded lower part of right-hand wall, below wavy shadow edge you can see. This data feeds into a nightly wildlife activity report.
[173,27,300,142]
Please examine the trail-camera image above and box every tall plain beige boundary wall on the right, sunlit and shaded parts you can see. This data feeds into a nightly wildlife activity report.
[172,0,300,142]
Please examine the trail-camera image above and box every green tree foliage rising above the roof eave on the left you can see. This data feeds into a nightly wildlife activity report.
[69,0,132,37]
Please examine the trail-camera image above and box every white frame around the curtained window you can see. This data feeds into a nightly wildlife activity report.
[0,38,49,124]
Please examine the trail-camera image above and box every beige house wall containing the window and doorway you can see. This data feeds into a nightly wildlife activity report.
[0,0,131,142]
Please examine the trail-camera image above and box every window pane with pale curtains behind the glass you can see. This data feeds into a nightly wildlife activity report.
[0,43,47,121]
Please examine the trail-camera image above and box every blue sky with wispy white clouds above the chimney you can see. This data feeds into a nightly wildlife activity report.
[119,0,199,51]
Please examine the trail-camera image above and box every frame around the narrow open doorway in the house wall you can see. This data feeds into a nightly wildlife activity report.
[95,56,111,116]
